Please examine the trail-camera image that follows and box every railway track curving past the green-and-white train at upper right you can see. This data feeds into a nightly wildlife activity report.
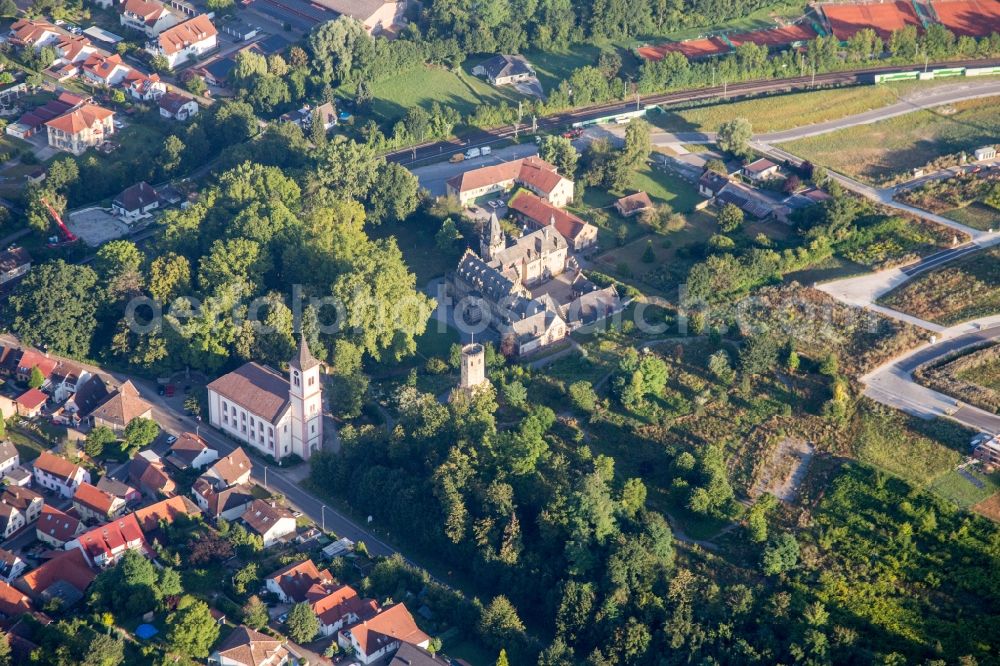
[385,59,1000,166]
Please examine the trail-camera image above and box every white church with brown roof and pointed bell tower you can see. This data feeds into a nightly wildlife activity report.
[208,337,323,462]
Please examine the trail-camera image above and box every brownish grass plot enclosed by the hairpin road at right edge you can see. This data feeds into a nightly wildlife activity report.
[913,344,1000,413]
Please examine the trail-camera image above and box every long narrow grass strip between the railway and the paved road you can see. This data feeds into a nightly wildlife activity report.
[650,79,996,134]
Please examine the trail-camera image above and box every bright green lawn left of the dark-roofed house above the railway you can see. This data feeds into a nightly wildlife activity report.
[372,65,524,121]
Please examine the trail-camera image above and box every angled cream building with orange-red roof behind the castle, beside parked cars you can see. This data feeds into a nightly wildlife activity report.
[445,157,573,208]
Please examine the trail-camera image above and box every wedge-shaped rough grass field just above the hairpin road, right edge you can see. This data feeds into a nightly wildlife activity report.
[878,248,1000,326]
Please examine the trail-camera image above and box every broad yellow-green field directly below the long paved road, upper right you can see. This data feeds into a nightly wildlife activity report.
[782,98,1000,185]
